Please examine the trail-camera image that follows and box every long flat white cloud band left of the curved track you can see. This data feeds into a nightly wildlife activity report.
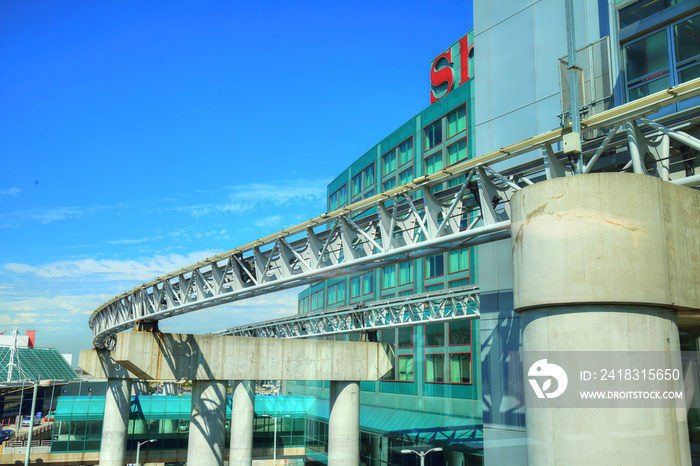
[4,250,220,282]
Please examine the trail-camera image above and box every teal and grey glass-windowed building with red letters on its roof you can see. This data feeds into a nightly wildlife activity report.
[288,0,700,465]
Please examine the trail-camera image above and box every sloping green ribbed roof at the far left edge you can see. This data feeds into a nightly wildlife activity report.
[0,346,79,385]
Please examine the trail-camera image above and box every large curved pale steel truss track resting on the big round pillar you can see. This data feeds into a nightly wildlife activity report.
[89,78,700,348]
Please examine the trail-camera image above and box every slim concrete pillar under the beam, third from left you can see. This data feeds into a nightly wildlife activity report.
[228,380,255,466]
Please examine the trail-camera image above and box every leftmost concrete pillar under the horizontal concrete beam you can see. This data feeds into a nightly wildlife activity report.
[100,379,131,466]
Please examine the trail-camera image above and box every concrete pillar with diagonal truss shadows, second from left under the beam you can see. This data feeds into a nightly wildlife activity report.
[187,380,228,466]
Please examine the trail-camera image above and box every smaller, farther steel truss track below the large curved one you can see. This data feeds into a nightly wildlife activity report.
[214,286,479,338]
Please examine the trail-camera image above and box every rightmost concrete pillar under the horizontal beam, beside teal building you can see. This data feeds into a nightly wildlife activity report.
[328,380,360,466]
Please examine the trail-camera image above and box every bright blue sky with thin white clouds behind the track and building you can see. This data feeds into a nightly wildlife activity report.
[0,0,472,362]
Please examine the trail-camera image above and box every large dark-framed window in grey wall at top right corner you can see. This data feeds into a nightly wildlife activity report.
[621,12,700,101]
